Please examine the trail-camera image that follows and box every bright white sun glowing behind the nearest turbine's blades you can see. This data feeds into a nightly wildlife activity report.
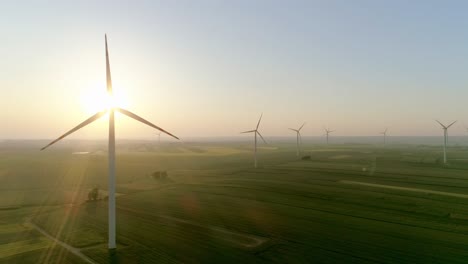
[80,85,128,114]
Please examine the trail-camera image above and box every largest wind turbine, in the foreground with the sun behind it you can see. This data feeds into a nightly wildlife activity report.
[41,35,179,251]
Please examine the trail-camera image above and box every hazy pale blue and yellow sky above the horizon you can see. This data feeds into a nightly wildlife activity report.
[0,0,468,139]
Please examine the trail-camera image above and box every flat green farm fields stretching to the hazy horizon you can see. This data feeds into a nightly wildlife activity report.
[0,142,468,263]
